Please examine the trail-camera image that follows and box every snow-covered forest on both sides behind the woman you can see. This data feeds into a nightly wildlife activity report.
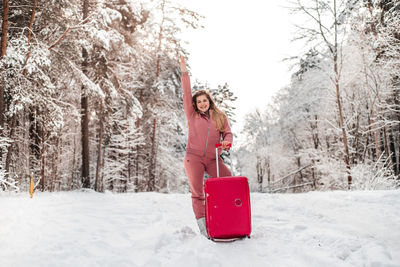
[0,0,400,193]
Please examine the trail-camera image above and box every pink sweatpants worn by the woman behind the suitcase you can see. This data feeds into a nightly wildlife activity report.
[185,153,232,219]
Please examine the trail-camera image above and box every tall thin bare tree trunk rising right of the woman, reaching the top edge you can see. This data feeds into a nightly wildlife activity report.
[333,0,352,189]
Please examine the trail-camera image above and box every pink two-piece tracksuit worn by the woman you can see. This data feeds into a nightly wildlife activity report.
[181,72,233,219]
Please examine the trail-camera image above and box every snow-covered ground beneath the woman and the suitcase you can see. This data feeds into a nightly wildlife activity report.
[0,190,400,267]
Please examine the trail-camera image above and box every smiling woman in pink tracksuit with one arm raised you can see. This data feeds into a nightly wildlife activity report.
[180,57,233,237]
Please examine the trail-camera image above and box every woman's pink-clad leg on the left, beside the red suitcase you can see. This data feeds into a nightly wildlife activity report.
[185,154,206,219]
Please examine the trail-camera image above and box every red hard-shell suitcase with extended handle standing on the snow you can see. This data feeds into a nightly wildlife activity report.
[204,144,251,240]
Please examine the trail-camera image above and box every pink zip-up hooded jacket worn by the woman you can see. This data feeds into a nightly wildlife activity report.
[181,72,233,159]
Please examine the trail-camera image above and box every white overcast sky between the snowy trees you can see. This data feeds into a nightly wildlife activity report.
[175,0,299,130]
